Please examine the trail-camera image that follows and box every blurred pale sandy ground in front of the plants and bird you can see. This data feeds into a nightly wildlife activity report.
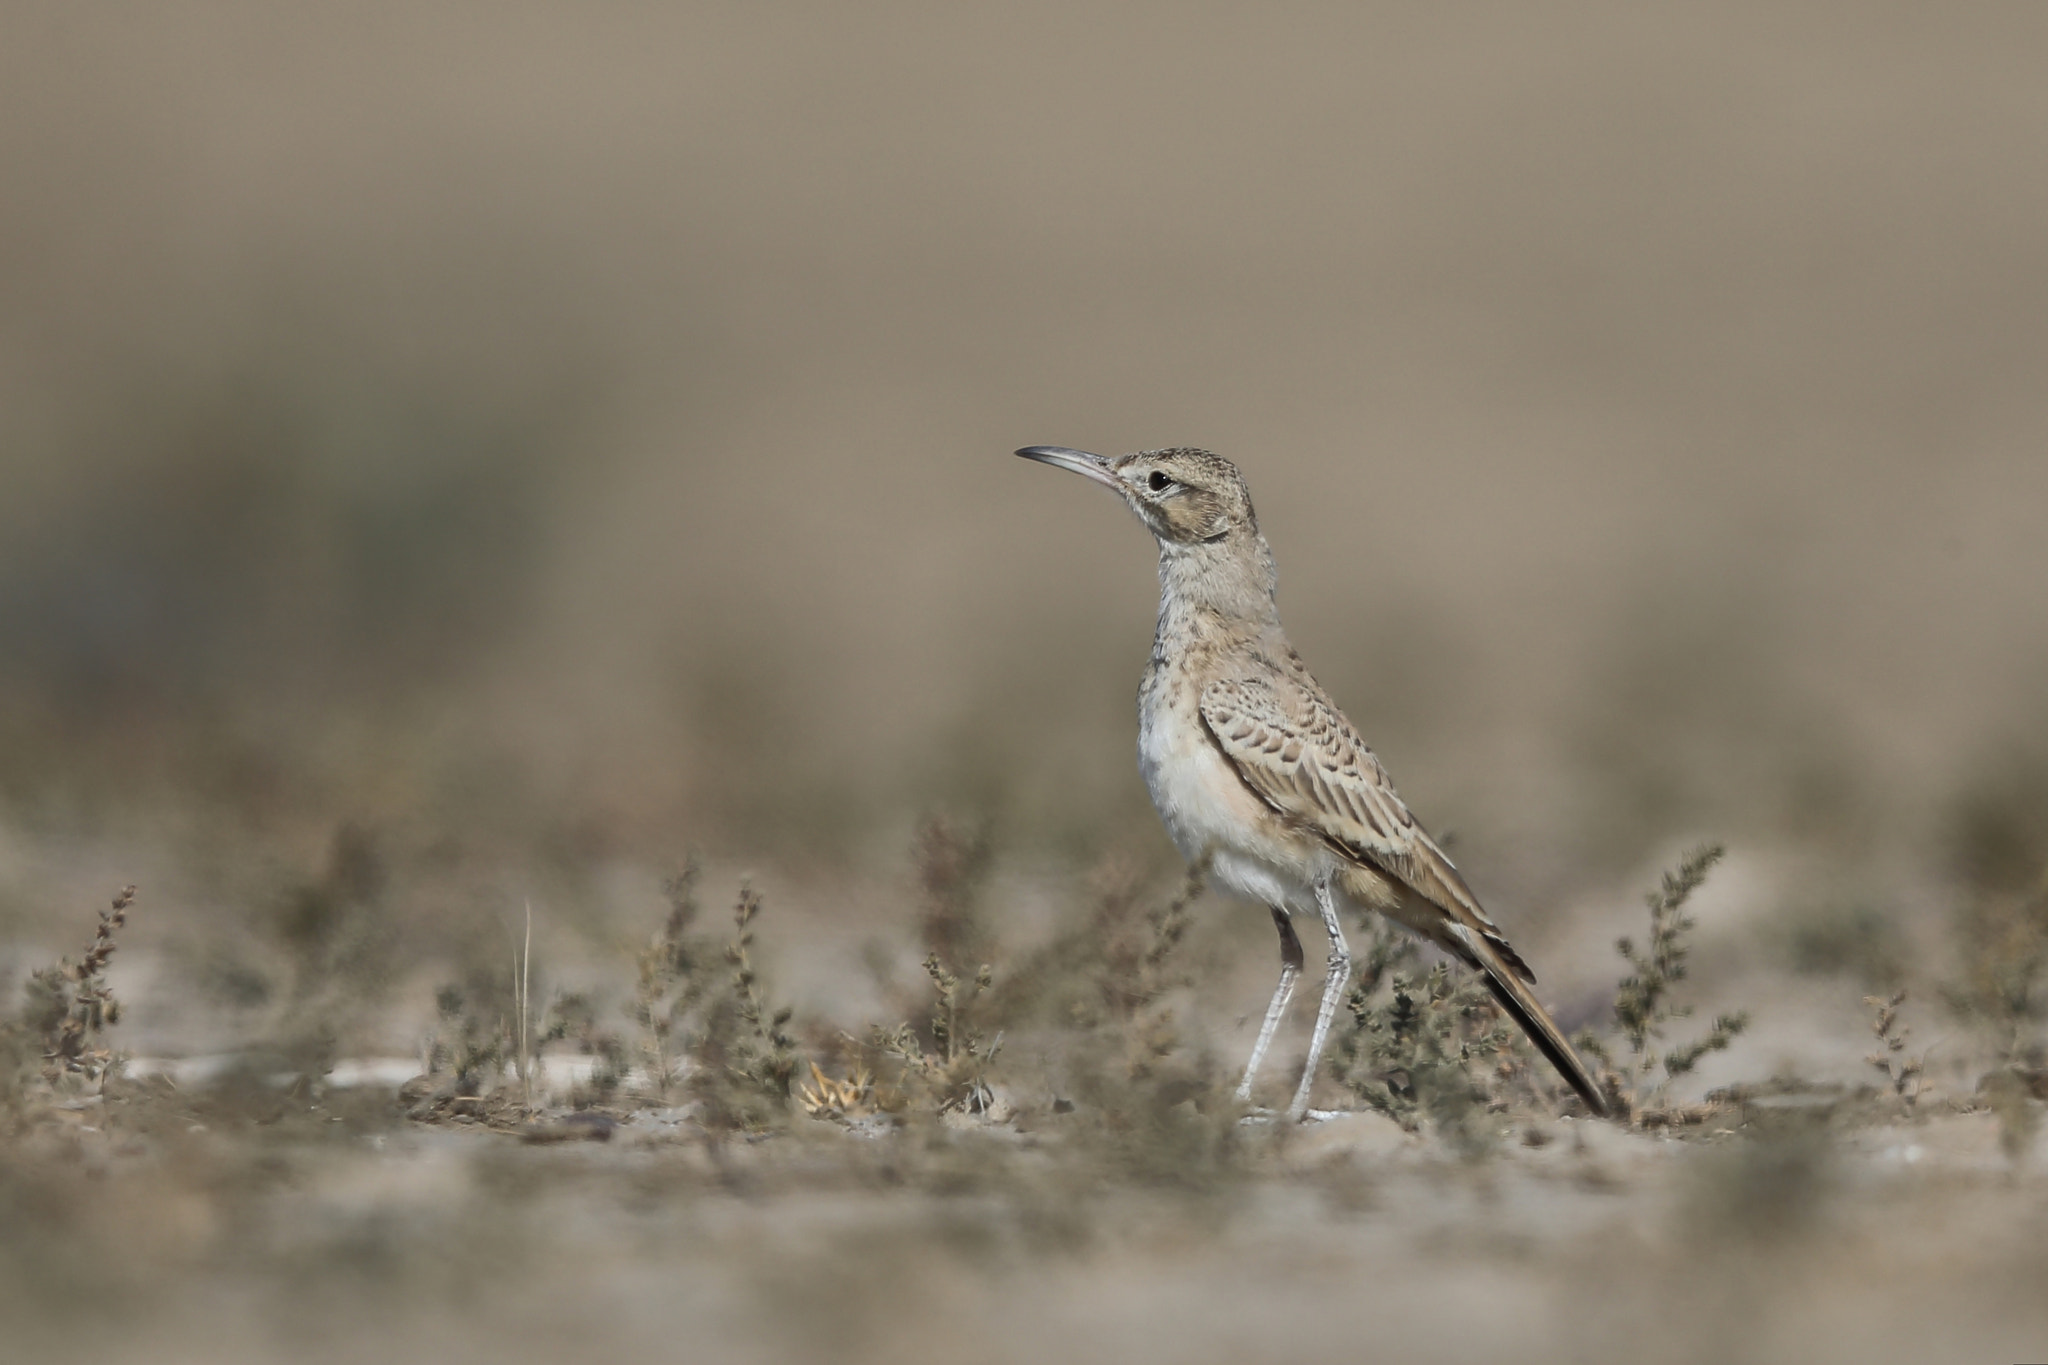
[0,1097,2048,1363]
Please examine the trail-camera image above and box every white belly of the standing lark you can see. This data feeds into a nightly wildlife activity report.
[1139,679,1337,915]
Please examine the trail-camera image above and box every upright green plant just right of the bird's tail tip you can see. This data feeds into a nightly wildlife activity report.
[1573,843,1749,1117]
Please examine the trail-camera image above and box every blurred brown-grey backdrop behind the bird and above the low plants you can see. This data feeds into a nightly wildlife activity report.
[0,4,2048,1064]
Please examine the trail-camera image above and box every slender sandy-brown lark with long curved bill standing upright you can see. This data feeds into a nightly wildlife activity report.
[1018,446,1608,1119]
